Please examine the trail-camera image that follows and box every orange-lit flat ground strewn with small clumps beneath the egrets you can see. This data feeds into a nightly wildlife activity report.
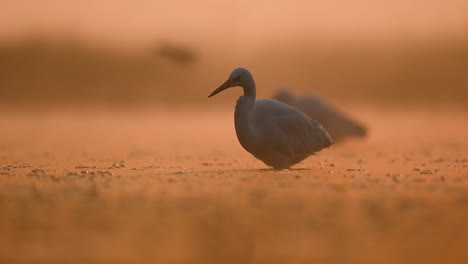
[0,108,468,263]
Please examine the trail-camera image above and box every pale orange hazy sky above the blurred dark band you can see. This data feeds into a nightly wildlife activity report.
[0,0,468,48]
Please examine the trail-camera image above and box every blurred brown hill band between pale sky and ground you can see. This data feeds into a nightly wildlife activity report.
[0,38,468,107]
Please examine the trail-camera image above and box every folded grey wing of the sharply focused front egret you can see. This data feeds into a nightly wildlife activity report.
[254,99,333,157]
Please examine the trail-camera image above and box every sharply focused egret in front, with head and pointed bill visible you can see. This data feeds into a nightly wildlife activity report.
[208,68,334,169]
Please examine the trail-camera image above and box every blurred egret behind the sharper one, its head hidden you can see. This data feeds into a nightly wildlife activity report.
[273,89,367,142]
